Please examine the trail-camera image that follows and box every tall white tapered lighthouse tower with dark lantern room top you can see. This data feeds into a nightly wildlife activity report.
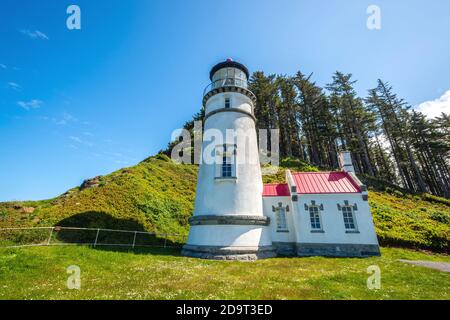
[182,59,276,260]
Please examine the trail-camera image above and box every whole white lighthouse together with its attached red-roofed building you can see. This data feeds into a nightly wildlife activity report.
[182,59,380,260]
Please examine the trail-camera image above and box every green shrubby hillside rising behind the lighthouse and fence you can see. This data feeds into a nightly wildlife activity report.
[0,155,450,253]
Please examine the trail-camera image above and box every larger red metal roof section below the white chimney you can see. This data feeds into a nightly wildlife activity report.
[292,172,361,194]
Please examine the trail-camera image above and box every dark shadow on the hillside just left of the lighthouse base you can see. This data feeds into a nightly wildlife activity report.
[55,211,182,256]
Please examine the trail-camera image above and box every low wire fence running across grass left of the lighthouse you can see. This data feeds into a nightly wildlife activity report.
[0,227,187,248]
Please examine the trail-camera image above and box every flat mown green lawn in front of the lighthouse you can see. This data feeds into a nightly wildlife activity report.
[0,247,450,300]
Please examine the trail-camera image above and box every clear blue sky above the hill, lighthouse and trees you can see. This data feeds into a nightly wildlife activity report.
[0,0,450,201]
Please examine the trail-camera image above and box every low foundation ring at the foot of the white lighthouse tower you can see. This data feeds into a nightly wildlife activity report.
[181,245,277,261]
